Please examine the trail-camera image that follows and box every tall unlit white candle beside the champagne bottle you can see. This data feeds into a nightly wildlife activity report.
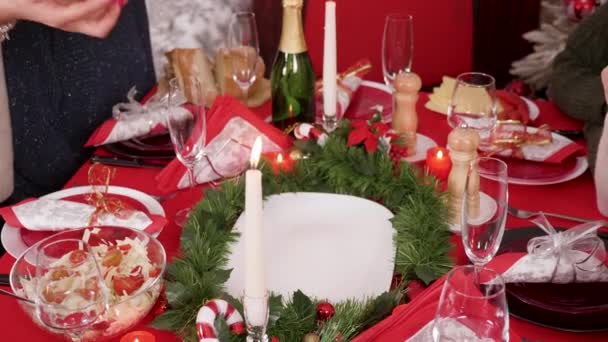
[323,1,338,116]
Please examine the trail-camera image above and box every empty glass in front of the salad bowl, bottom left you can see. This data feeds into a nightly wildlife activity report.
[36,239,108,341]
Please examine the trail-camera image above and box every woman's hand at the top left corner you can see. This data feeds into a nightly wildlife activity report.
[0,0,126,38]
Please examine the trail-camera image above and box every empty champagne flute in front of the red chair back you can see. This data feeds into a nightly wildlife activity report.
[382,14,414,88]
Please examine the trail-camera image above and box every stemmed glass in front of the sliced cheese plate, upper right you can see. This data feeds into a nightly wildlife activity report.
[448,72,497,132]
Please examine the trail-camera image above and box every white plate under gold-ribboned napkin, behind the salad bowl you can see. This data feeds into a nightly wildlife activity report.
[0,185,165,258]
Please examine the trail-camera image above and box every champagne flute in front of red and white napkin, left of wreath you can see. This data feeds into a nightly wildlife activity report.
[166,76,207,227]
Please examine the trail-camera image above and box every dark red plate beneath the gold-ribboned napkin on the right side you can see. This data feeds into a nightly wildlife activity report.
[503,157,576,181]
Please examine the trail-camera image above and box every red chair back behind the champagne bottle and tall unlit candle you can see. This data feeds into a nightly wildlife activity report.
[304,0,473,86]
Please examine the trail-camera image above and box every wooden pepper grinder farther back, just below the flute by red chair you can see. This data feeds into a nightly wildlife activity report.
[393,72,422,156]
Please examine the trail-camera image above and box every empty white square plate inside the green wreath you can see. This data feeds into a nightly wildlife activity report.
[226,193,395,303]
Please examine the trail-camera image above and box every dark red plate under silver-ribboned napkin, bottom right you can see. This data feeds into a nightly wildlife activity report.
[499,227,608,332]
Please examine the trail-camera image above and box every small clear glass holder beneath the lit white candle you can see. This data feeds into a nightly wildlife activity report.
[243,292,269,342]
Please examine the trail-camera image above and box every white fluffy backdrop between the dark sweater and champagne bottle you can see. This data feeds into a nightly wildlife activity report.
[146,0,252,78]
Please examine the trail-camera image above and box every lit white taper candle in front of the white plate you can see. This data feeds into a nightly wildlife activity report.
[244,137,266,298]
